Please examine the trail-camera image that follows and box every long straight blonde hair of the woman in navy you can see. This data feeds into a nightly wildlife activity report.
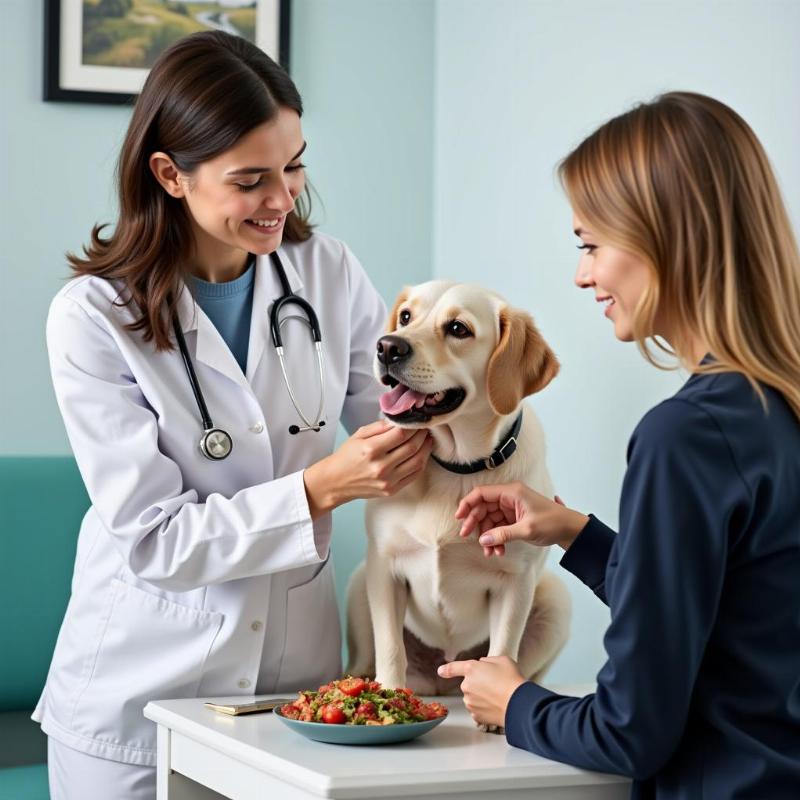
[559,92,800,419]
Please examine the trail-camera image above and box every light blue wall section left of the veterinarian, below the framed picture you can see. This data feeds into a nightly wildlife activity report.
[0,0,129,455]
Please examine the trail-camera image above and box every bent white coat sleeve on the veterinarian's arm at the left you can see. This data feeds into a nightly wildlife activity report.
[47,295,322,591]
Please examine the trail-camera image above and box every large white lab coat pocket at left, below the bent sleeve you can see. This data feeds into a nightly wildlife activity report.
[73,579,224,749]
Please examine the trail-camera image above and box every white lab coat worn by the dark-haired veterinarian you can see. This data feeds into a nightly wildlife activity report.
[33,233,386,766]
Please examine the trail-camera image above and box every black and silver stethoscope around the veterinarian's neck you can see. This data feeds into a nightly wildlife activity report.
[172,252,325,461]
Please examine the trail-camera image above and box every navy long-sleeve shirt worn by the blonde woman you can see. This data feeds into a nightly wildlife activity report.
[505,373,800,800]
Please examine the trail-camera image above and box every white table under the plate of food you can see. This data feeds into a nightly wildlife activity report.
[144,686,630,800]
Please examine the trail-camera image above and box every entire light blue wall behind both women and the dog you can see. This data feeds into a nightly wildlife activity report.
[0,0,800,681]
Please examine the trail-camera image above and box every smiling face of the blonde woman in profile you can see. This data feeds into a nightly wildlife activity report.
[572,214,651,342]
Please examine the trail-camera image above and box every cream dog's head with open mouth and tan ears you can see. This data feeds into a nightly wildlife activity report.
[374,281,558,427]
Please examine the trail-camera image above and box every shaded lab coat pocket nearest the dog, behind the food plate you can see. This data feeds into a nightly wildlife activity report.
[276,557,342,692]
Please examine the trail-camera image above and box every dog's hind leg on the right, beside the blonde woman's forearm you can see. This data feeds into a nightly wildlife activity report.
[517,570,572,683]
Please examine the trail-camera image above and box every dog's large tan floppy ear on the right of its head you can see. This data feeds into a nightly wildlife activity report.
[486,306,559,414]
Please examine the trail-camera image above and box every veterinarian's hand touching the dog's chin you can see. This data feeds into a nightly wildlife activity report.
[303,420,433,519]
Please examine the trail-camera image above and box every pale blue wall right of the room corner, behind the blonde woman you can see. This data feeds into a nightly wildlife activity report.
[434,0,800,681]
